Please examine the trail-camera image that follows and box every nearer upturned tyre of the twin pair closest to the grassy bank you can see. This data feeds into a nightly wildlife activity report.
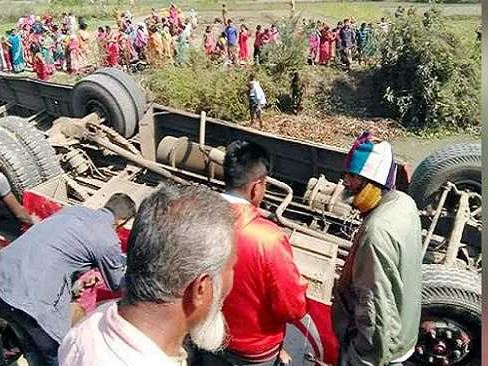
[71,74,139,138]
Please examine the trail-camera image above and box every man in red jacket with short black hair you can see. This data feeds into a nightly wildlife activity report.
[201,141,306,366]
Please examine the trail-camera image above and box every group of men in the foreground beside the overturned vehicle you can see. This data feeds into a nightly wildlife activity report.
[0,133,422,366]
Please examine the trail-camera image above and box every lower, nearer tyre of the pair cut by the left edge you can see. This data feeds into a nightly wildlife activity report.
[0,129,42,198]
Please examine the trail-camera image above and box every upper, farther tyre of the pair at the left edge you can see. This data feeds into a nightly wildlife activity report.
[0,116,63,180]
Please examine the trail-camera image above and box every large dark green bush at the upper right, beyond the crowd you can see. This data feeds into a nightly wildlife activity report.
[377,9,481,130]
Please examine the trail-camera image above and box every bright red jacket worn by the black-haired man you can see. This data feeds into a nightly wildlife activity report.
[223,203,305,357]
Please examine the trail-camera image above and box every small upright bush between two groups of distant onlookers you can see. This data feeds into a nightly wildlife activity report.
[263,14,307,75]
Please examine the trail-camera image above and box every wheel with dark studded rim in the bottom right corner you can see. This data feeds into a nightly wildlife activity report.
[413,265,481,365]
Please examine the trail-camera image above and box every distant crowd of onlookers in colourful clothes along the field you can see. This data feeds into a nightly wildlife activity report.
[0,4,396,80]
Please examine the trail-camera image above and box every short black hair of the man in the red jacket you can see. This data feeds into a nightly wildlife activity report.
[224,140,271,189]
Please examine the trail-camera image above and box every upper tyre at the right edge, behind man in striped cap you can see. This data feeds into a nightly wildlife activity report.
[409,144,481,209]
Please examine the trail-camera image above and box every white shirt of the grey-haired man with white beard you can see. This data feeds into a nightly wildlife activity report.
[58,301,186,366]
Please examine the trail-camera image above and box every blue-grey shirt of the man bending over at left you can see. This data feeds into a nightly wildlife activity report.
[0,207,123,342]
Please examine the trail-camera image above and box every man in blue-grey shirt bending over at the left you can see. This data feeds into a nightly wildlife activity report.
[0,193,136,366]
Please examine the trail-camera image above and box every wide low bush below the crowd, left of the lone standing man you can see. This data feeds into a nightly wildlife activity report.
[146,50,279,122]
